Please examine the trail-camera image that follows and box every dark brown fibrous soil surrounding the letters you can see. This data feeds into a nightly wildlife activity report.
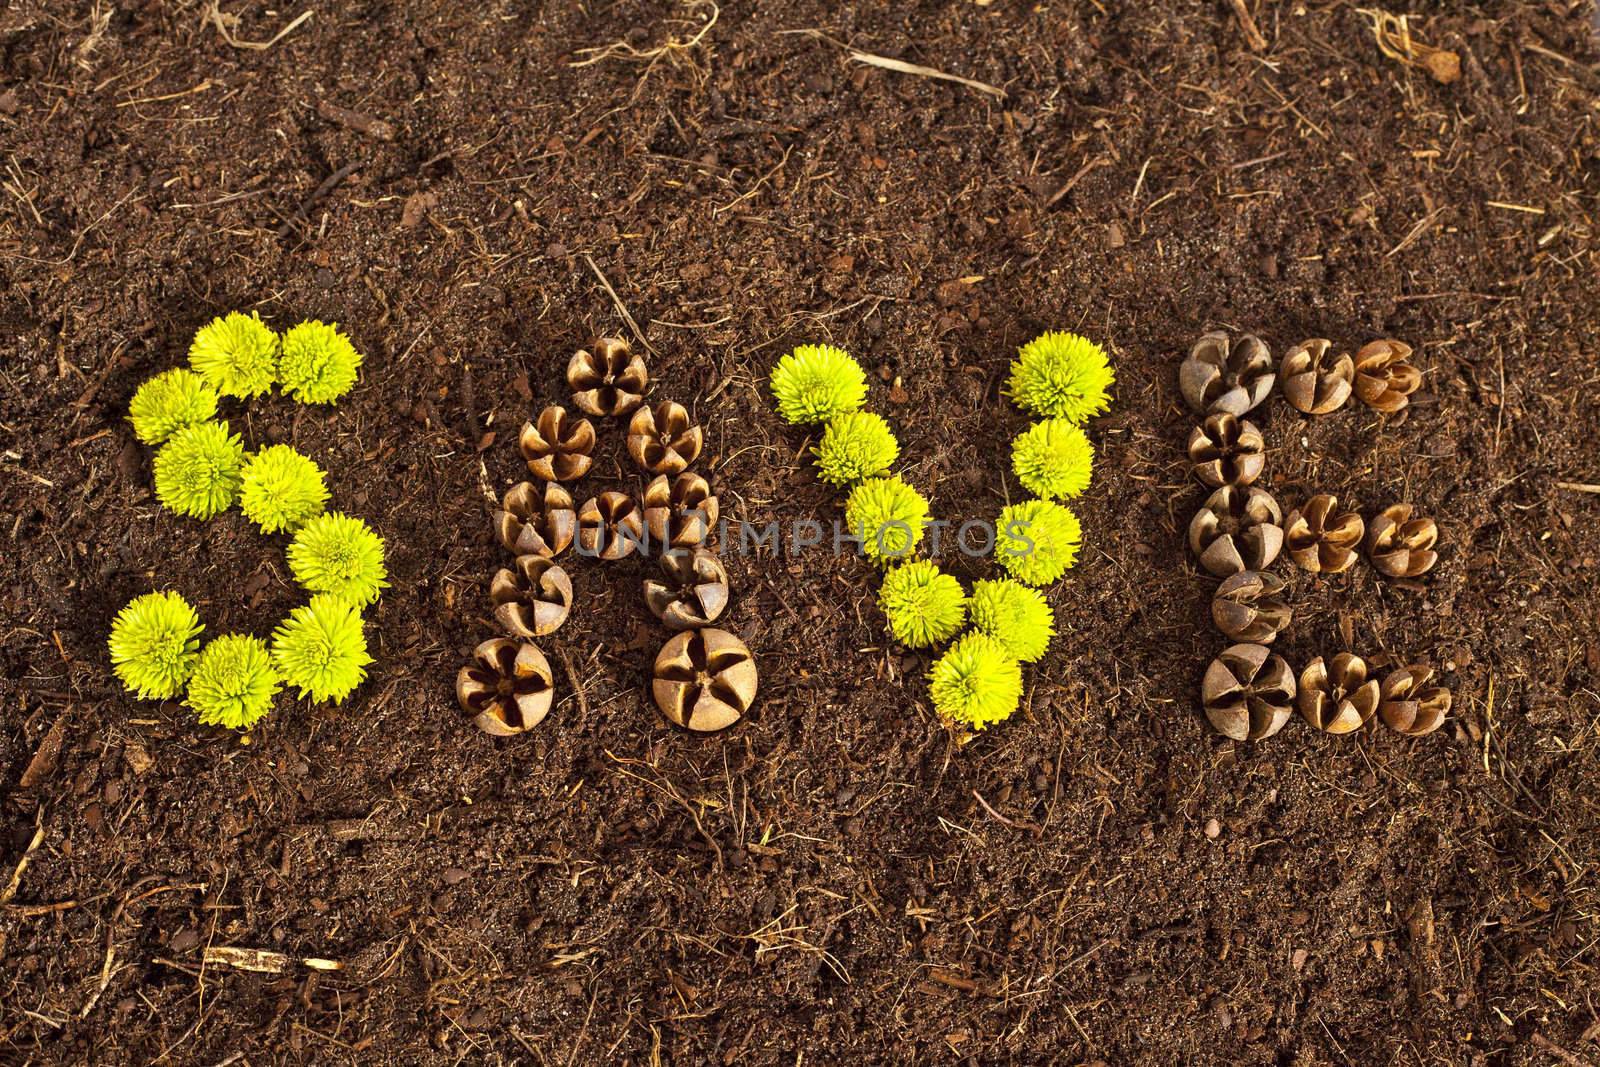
[0,0,1600,1065]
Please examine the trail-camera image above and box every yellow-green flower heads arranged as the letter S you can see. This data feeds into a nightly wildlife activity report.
[109,312,379,729]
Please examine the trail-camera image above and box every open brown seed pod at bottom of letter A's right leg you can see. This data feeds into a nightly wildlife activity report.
[650,625,758,733]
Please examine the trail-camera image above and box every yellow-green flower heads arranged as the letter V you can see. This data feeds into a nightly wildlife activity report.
[770,333,1114,729]
